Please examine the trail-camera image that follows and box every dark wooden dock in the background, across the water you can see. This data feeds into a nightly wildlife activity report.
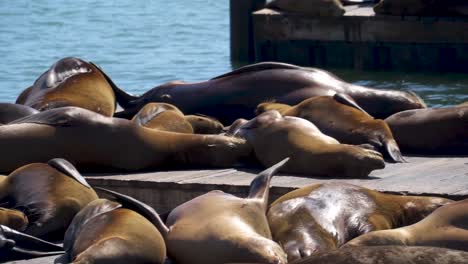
[231,0,468,72]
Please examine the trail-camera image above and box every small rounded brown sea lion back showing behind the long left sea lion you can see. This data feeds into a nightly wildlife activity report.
[132,103,193,134]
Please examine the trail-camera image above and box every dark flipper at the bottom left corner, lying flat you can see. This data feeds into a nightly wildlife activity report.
[0,225,65,257]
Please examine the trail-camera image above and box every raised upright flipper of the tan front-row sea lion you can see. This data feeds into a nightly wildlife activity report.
[248,157,289,210]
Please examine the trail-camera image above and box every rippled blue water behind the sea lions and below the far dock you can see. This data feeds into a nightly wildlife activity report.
[0,0,468,106]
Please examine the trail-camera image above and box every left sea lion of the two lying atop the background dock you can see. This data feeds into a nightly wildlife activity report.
[265,0,345,16]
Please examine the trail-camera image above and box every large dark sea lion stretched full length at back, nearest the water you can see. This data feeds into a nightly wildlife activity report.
[113,62,425,124]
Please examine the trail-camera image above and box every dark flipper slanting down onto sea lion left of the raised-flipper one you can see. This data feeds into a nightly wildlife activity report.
[95,187,169,238]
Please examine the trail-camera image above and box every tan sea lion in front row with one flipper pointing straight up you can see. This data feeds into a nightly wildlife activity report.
[160,159,287,264]
